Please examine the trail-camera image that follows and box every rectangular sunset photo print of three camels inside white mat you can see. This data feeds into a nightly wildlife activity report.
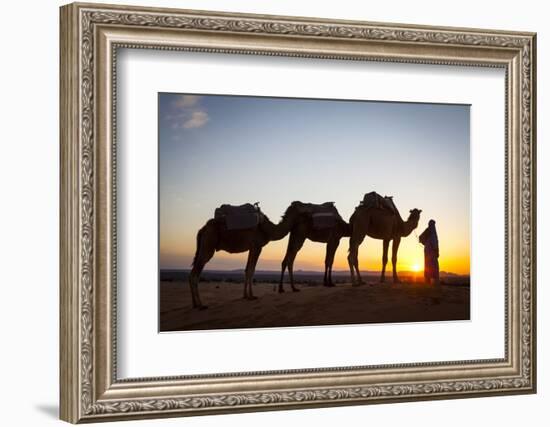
[158,93,470,332]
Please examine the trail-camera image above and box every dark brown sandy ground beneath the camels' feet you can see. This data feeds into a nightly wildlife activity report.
[160,281,470,331]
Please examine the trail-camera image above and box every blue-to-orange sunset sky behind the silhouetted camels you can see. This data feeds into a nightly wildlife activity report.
[158,93,470,274]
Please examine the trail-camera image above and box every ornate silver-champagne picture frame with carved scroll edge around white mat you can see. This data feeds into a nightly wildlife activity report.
[60,4,536,423]
